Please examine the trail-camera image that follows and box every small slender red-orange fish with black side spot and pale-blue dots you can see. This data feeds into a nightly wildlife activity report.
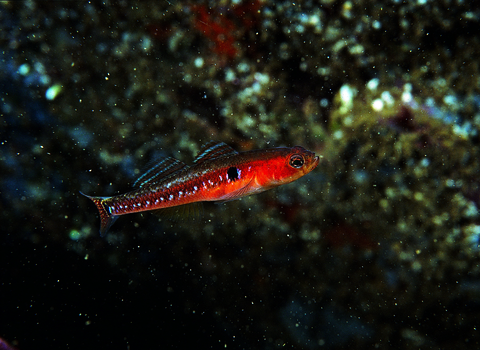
[80,141,320,236]
